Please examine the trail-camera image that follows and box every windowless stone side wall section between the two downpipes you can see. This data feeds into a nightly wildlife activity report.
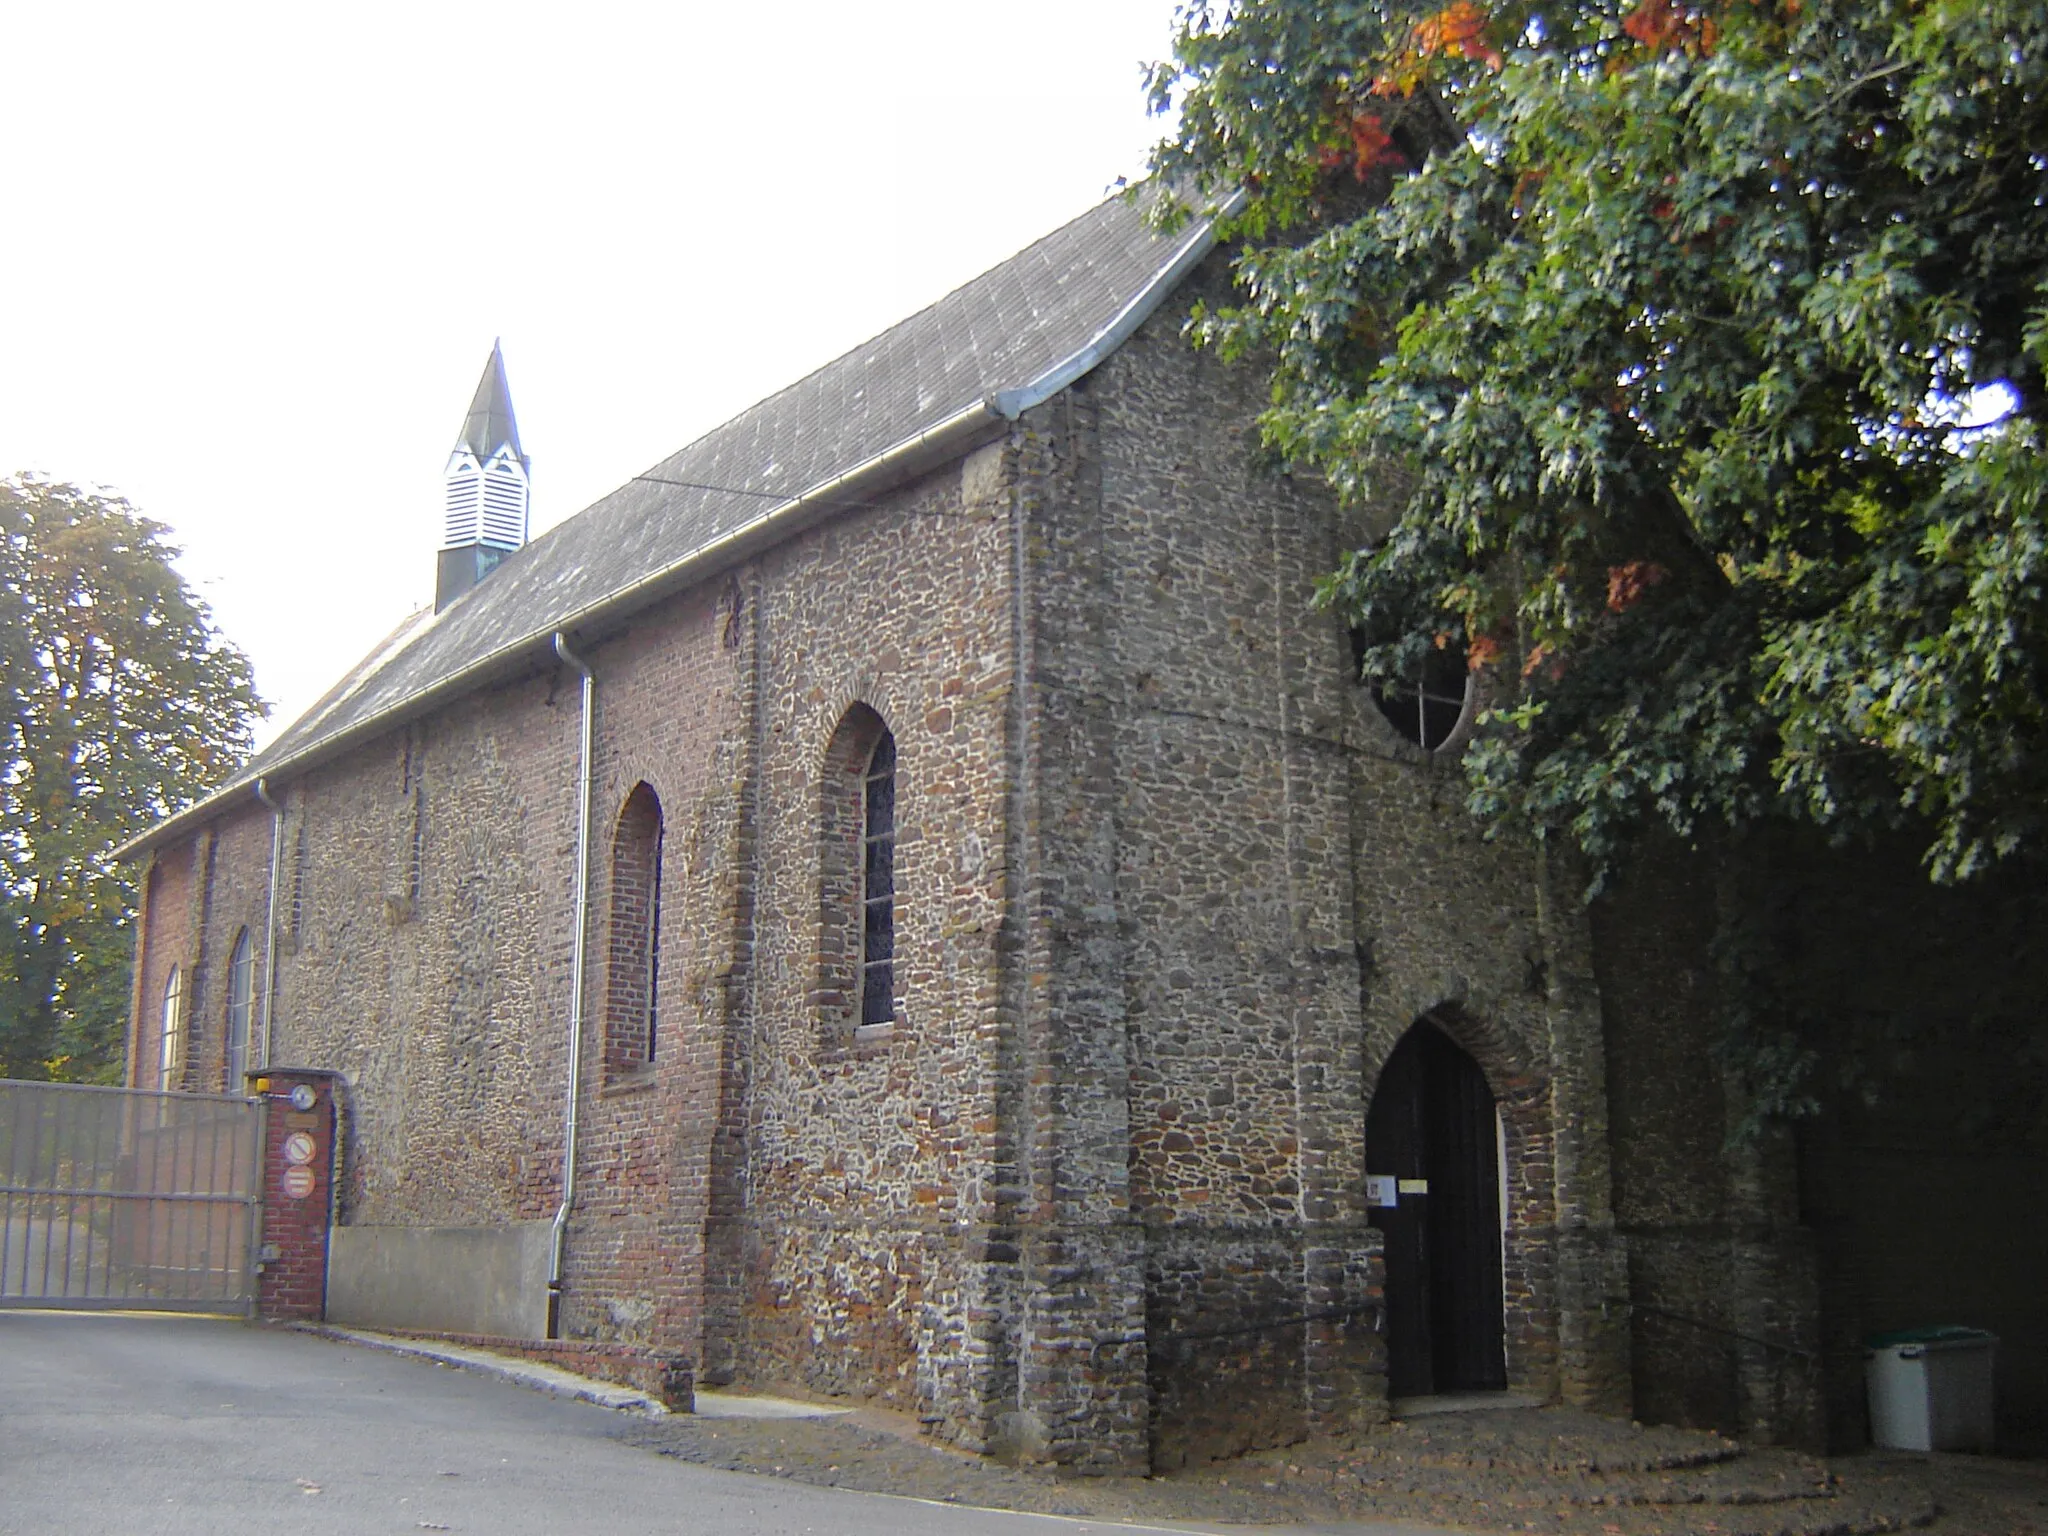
[272,668,578,1227]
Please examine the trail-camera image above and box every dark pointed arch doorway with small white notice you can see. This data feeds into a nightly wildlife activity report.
[1366,1018,1507,1397]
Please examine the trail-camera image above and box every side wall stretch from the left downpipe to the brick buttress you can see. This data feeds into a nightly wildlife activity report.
[239,569,743,1360]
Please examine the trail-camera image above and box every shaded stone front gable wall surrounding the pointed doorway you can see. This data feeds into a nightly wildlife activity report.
[1040,256,1628,1462]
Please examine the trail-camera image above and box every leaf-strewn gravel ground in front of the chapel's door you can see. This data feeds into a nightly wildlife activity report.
[621,1409,2048,1536]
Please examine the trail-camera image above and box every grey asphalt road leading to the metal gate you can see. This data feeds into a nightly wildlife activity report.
[0,1311,1245,1536]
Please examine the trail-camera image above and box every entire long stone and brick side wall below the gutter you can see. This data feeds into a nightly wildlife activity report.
[131,465,1014,1444]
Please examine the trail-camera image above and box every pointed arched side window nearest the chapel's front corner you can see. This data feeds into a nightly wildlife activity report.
[817,705,897,1038]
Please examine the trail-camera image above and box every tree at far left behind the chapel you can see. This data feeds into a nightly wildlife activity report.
[0,475,262,1079]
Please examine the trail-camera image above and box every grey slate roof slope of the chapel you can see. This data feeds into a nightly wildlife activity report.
[121,197,1212,854]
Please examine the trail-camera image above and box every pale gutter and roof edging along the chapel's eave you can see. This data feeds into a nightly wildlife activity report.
[115,190,1245,860]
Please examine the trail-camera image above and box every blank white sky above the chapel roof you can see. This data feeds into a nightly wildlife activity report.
[0,0,1171,739]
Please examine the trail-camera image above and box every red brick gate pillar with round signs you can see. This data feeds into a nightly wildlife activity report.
[250,1067,340,1321]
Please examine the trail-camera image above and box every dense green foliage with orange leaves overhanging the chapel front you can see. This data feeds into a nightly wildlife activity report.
[1153,0,2048,879]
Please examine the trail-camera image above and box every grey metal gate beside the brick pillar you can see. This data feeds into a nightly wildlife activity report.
[0,1079,262,1315]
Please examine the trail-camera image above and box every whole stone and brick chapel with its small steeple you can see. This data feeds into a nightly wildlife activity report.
[127,189,2048,1473]
